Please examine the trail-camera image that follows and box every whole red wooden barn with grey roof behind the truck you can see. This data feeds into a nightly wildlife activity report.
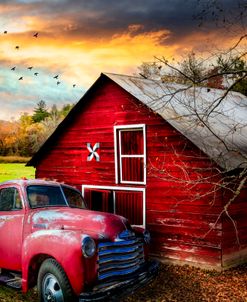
[28,74,247,269]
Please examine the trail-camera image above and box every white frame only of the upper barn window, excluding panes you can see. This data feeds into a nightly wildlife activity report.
[114,124,147,185]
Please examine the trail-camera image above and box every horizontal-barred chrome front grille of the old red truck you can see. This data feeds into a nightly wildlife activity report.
[98,231,144,281]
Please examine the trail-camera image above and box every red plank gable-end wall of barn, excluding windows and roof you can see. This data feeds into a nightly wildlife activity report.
[36,80,222,266]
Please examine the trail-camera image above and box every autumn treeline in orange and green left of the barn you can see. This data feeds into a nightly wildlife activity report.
[0,101,73,157]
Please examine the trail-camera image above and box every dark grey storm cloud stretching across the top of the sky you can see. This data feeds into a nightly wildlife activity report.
[0,0,246,43]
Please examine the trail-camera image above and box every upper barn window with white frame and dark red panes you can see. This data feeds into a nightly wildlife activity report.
[114,124,146,184]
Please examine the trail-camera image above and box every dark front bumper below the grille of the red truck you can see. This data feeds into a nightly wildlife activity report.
[79,260,159,302]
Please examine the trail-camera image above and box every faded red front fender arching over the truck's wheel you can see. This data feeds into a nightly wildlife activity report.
[22,230,84,294]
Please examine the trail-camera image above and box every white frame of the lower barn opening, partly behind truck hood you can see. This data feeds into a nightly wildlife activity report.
[82,185,146,228]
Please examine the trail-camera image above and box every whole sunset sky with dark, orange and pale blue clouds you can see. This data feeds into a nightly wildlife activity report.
[0,0,247,120]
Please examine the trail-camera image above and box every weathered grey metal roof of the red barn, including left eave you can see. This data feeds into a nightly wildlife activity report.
[28,73,247,170]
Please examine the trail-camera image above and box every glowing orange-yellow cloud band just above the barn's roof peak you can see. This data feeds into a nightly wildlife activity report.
[1,22,243,92]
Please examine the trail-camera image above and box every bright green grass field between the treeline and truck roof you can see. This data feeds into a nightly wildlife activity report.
[0,163,35,182]
